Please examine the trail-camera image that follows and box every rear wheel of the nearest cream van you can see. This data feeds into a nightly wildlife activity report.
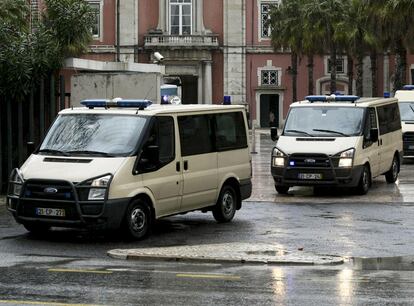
[213,185,237,223]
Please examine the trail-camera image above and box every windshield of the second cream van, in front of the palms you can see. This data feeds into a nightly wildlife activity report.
[283,106,364,137]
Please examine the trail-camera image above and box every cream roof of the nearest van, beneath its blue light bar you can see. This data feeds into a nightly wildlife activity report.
[59,104,245,116]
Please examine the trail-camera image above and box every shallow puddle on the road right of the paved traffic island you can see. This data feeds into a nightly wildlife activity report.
[352,256,414,271]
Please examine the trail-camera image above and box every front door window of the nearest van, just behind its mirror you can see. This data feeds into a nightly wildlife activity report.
[157,117,175,165]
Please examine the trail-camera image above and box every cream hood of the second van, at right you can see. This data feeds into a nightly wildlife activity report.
[276,136,359,155]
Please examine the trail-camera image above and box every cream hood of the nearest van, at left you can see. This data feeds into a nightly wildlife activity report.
[20,154,126,183]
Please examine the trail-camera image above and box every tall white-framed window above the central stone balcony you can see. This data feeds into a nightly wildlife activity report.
[170,0,192,35]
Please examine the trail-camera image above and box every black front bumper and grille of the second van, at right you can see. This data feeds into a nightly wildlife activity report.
[271,154,363,187]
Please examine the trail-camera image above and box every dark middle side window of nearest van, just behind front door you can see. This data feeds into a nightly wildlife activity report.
[178,115,214,156]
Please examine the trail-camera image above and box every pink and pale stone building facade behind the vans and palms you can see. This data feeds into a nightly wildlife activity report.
[60,0,414,127]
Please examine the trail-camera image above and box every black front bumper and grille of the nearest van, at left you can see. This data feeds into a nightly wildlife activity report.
[7,180,130,229]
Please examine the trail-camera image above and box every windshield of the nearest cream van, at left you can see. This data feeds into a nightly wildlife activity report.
[39,114,148,157]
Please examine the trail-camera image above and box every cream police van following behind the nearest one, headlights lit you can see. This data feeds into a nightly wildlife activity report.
[271,95,402,194]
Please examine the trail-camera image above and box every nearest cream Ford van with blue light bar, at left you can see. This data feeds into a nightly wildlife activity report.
[7,100,252,239]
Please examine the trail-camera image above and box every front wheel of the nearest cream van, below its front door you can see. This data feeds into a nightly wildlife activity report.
[123,200,151,240]
